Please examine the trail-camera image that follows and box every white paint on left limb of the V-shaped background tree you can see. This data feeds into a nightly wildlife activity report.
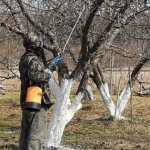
[99,83,115,116]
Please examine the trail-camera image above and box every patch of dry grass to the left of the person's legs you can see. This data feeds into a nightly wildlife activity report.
[0,93,21,150]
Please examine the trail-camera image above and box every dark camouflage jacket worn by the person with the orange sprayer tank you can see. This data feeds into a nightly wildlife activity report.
[19,51,51,108]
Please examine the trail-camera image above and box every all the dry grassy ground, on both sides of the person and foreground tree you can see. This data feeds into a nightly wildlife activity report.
[0,92,150,150]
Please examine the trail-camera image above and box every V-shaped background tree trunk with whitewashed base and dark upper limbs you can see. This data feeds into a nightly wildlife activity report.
[93,51,150,120]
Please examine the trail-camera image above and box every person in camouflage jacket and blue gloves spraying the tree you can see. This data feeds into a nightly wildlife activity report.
[19,33,59,150]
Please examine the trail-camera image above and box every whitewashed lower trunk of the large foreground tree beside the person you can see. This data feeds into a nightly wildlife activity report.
[44,79,83,148]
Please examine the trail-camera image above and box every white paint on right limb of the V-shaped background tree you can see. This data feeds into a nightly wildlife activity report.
[115,84,131,120]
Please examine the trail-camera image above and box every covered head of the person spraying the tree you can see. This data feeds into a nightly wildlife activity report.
[23,32,43,51]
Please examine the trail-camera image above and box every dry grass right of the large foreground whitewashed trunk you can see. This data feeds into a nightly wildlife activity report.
[63,97,150,150]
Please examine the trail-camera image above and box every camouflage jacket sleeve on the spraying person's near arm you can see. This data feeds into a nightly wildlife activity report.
[28,57,50,82]
